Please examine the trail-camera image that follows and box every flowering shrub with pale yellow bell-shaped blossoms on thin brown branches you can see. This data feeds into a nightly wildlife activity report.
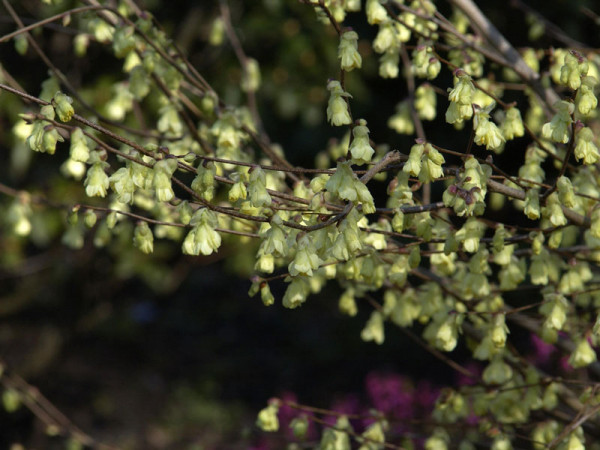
[0,0,600,450]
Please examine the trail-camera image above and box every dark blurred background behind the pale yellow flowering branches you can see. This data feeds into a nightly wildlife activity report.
[0,0,599,449]
